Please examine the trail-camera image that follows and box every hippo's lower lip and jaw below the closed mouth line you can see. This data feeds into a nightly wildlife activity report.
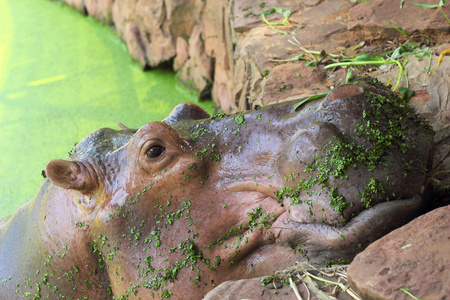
[227,194,423,277]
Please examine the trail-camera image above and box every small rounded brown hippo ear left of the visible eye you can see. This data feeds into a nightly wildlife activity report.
[45,160,98,195]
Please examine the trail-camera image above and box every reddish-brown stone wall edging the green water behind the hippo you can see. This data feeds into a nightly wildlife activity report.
[64,0,450,113]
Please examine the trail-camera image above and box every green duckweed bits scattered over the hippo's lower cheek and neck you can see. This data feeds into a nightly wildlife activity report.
[9,179,202,299]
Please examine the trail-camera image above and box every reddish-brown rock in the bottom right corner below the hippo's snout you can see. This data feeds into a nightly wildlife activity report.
[347,206,450,300]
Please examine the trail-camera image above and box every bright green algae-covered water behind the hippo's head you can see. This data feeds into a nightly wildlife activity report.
[0,0,213,218]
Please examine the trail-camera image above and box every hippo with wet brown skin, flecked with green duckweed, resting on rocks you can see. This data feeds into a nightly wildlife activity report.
[0,79,433,299]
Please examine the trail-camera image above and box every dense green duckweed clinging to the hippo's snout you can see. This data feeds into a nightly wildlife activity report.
[275,77,432,222]
